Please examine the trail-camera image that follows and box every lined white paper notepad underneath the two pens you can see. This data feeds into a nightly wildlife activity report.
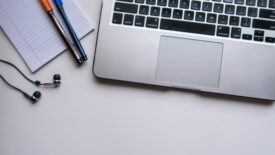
[0,0,93,72]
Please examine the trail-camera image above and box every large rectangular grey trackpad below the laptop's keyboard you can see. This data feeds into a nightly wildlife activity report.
[156,36,223,87]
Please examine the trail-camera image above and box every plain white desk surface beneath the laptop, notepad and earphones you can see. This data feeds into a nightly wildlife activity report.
[0,0,275,155]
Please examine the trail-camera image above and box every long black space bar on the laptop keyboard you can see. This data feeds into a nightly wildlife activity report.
[160,19,215,35]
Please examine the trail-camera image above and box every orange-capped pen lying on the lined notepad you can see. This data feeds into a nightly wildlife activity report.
[40,0,83,64]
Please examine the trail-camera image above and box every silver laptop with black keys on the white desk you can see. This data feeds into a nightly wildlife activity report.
[93,0,275,100]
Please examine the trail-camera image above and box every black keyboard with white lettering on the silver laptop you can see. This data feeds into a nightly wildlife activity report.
[112,0,275,43]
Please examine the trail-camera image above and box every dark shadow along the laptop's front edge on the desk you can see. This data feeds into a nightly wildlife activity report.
[95,77,273,106]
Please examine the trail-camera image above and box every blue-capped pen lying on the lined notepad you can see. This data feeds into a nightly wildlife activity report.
[54,0,88,61]
